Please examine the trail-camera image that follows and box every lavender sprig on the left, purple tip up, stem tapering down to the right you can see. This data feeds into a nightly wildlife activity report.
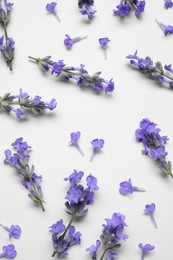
[4,137,45,211]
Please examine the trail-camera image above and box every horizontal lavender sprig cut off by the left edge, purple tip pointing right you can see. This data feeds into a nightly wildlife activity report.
[0,89,57,119]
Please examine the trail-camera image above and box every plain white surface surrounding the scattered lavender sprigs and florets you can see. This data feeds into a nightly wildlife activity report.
[0,0,173,260]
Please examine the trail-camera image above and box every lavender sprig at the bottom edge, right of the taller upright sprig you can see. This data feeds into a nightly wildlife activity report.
[86,213,128,260]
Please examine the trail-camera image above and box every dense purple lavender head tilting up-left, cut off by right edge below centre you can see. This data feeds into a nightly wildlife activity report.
[135,118,173,178]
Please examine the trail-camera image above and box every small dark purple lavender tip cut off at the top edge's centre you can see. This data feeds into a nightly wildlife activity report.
[78,0,97,20]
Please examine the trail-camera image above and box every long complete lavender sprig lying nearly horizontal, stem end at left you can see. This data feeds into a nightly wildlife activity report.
[29,56,114,93]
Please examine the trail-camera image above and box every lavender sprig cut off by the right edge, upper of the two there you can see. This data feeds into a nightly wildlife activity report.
[126,51,173,89]
